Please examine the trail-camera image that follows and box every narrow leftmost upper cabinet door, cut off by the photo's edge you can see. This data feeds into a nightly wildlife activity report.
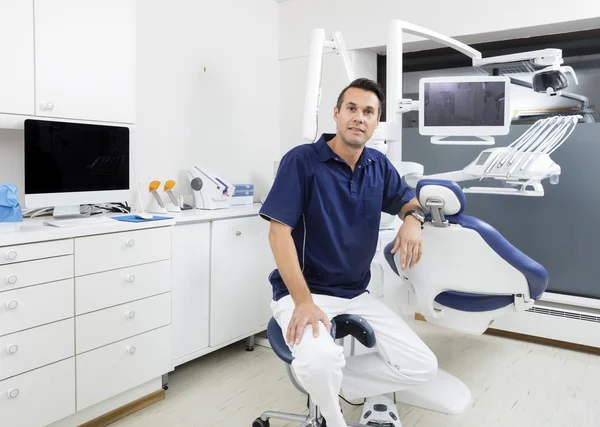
[0,0,34,115]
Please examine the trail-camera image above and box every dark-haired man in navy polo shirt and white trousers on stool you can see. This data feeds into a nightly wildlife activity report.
[260,79,437,427]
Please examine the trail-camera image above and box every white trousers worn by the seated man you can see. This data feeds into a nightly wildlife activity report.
[271,293,437,427]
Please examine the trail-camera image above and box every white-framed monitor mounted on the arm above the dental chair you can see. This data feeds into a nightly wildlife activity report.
[419,76,511,143]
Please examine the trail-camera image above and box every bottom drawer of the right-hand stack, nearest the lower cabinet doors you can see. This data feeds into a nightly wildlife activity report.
[76,326,171,411]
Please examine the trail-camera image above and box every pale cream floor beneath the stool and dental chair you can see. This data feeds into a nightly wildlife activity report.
[111,322,600,427]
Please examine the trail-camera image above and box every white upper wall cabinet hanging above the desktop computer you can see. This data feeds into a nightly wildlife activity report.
[0,0,135,123]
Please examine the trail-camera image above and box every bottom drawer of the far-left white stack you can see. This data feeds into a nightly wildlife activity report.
[0,358,75,427]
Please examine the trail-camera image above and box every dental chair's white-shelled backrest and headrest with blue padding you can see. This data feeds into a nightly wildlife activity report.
[385,180,548,320]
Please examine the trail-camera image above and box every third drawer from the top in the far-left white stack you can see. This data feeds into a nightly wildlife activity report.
[0,279,75,336]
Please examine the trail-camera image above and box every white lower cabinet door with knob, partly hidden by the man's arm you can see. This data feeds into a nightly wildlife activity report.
[210,216,275,347]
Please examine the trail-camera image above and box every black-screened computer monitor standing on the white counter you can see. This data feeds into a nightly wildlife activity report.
[24,119,130,217]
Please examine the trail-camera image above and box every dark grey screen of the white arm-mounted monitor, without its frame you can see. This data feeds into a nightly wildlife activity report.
[423,82,506,126]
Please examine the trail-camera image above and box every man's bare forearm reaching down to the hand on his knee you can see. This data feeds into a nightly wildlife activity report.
[269,231,312,306]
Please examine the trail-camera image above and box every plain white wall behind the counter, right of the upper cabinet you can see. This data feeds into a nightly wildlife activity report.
[0,0,280,210]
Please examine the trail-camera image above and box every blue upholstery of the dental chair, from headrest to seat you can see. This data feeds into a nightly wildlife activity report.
[384,179,548,312]
